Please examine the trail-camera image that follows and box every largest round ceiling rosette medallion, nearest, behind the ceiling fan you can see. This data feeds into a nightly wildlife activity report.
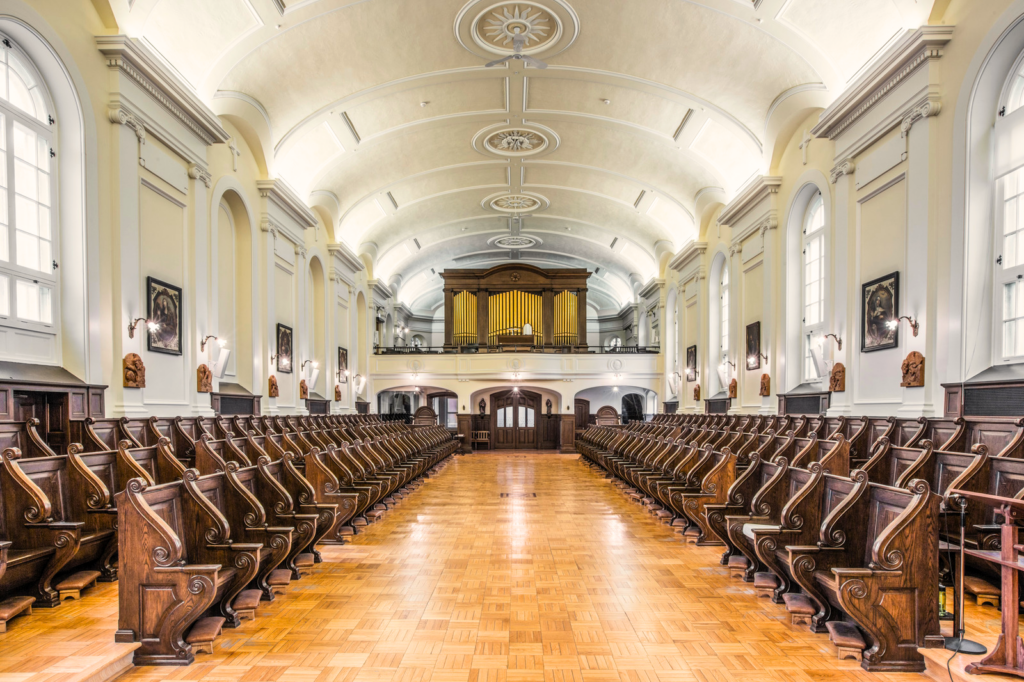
[455,0,580,57]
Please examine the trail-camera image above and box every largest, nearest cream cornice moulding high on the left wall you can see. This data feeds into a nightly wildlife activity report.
[96,35,230,145]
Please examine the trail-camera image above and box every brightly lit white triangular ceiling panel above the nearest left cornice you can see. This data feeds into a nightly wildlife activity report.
[141,0,262,87]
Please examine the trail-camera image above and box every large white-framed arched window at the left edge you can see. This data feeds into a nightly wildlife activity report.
[0,36,59,334]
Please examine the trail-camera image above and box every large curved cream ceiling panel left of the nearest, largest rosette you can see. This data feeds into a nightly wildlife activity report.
[220,0,482,136]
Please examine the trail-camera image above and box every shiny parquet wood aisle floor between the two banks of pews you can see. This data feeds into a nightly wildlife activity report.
[120,451,901,682]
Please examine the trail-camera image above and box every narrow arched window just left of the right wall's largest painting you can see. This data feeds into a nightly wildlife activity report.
[801,191,825,381]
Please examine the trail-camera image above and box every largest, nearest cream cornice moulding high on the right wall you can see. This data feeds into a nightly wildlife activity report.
[811,26,953,139]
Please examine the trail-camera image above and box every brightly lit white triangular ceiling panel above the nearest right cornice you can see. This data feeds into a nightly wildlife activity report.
[779,0,909,80]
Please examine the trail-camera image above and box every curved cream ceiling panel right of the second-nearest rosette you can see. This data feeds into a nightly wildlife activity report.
[537,118,724,208]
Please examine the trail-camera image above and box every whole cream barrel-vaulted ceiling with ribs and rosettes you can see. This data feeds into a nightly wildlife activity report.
[111,0,932,312]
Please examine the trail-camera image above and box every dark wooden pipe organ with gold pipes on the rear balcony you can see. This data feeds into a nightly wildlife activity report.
[441,263,590,349]
